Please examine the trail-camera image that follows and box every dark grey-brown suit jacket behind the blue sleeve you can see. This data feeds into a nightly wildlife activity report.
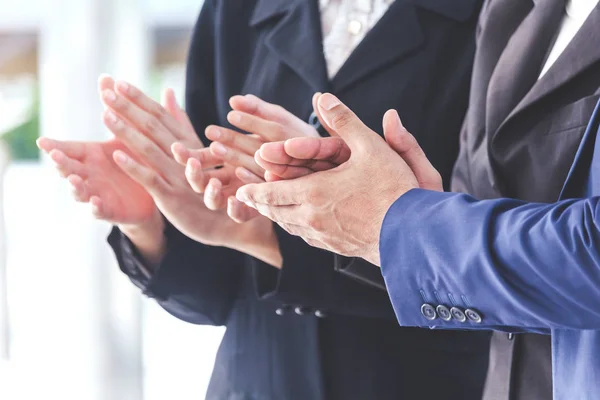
[452,0,600,400]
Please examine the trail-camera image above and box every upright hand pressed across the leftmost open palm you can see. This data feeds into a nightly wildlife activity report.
[102,78,282,267]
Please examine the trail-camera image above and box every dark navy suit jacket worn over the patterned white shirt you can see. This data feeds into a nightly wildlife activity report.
[109,0,489,400]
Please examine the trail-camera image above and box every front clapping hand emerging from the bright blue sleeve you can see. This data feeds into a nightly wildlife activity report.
[237,94,441,265]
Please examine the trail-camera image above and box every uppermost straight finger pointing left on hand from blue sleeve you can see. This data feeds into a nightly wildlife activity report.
[236,179,311,206]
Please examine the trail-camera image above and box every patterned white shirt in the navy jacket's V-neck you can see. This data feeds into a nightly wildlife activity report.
[320,0,394,78]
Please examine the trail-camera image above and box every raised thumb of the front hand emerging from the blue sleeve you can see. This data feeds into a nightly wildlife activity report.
[317,93,379,150]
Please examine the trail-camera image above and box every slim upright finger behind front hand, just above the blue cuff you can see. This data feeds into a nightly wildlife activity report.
[383,110,443,191]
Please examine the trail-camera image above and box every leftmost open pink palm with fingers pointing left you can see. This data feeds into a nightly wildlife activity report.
[38,76,201,264]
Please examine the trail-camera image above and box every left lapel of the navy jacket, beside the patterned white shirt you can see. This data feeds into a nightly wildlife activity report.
[250,0,329,91]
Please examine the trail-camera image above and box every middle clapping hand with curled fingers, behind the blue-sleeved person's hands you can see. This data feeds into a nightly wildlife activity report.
[172,95,319,217]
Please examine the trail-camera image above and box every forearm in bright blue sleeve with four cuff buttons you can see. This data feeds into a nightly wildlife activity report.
[380,190,600,330]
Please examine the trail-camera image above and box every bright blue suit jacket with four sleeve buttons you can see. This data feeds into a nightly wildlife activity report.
[380,98,600,400]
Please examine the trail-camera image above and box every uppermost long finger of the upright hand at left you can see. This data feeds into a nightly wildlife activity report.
[115,81,194,145]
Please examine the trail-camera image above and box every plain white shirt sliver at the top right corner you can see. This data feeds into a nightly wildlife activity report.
[540,0,599,78]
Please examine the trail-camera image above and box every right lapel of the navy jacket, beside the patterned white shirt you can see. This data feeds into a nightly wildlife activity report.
[332,0,480,93]
